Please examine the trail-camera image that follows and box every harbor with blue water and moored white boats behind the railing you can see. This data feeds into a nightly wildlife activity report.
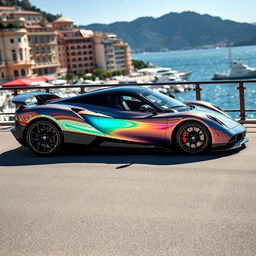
[0,46,256,121]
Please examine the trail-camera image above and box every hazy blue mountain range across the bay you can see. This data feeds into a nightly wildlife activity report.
[81,12,256,51]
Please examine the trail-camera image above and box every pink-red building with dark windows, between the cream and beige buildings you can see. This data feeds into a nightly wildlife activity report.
[53,17,96,74]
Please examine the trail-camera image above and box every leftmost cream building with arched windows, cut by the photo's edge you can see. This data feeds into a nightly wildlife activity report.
[0,18,33,81]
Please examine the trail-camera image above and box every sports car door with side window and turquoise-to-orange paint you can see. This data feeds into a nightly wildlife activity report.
[98,94,168,144]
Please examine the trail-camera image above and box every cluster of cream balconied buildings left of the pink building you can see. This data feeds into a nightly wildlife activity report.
[0,7,62,81]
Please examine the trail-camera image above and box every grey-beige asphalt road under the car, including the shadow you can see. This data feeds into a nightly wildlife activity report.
[0,132,256,256]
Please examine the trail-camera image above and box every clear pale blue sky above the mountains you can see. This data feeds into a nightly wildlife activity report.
[30,0,256,25]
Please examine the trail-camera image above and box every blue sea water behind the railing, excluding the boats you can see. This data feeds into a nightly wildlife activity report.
[133,46,256,118]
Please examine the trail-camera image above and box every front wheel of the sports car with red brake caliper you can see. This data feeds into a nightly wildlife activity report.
[176,121,211,154]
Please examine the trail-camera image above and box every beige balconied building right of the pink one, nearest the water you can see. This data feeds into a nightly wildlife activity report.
[94,32,133,74]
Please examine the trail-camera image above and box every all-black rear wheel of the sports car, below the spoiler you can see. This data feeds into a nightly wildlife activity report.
[26,120,62,156]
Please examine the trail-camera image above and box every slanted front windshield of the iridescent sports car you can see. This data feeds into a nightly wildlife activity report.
[142,90,187,112]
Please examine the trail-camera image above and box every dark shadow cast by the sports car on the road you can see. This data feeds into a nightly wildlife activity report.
[0,145,244,169]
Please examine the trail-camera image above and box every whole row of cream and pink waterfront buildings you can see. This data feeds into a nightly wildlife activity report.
[0,6,132,83]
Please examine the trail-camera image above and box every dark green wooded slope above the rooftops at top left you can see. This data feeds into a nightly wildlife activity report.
[0,0,60,22]
